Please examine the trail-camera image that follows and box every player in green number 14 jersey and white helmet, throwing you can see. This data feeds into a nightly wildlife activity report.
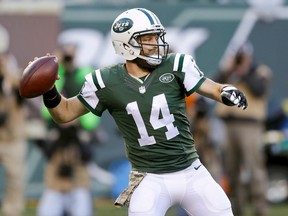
[43,8,247,216]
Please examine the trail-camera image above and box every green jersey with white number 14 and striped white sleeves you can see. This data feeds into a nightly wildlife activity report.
[78,53,205,173]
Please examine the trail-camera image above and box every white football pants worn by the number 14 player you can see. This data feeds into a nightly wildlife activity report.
[129,160,233,216]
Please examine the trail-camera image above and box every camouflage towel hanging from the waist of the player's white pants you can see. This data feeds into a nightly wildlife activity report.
[114,171,146,208]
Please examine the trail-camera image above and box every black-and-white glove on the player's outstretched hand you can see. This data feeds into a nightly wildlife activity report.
[221,86,248,110]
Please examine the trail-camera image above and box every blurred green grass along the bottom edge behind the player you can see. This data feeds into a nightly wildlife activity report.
[24,199,288,216]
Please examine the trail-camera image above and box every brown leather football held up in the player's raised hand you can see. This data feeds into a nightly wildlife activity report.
[19,55,58,98]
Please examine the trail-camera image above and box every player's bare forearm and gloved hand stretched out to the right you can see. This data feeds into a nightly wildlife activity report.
[197,78,248,110]
